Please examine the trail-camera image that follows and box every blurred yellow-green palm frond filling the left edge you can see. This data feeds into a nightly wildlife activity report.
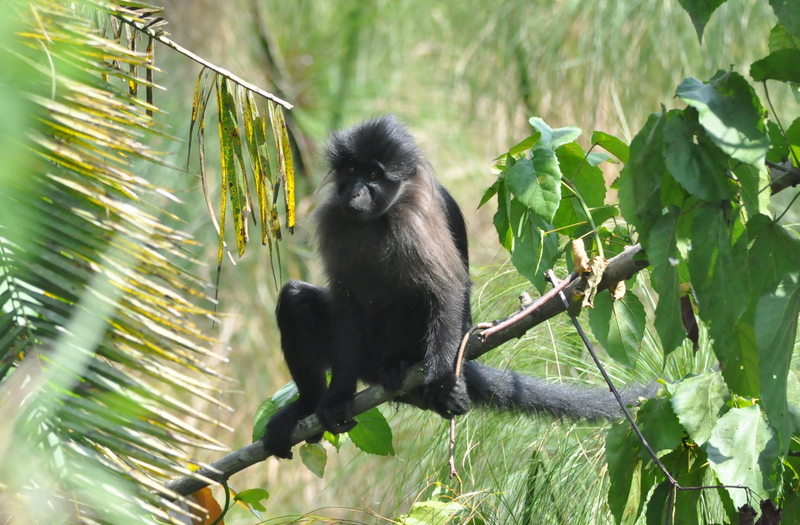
[0,0,244,523]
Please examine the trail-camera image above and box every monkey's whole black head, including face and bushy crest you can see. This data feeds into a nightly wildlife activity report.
[326,115,424,221]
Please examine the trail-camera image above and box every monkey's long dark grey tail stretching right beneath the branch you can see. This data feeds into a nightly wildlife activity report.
[464,361,660,420]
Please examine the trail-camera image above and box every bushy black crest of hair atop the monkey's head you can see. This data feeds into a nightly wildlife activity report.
[325,115,427,181]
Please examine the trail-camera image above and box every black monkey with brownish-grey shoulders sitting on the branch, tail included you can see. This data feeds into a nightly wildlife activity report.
[262,115,640,458]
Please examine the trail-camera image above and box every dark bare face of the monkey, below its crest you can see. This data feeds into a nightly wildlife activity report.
[334,161,404,221]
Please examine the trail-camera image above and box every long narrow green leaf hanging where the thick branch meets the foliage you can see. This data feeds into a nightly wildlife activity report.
[647,210,686,356]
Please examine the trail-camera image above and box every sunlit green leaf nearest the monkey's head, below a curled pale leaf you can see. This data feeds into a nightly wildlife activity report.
[506,148,561,222]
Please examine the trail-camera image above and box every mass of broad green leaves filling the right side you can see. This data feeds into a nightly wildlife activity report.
[484,2,800,523]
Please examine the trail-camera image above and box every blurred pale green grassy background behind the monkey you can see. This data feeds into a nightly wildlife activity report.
[141,0,784,523]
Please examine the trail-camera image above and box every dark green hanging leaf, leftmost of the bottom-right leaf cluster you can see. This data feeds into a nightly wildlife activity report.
[605,422,640,524]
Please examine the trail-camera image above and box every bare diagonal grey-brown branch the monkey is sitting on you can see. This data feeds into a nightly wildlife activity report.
[165,244,648,498]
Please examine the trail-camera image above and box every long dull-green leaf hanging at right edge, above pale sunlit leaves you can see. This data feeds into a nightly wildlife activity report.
[755,269,800,454]
